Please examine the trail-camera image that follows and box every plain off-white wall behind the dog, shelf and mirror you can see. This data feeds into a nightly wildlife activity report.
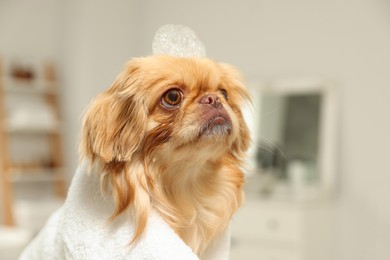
[0,0,390,260]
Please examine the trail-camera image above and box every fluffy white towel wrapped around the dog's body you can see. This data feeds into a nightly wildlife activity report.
[20,164,230,260]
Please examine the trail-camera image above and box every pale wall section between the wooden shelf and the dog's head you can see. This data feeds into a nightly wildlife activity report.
[59,0,141,174]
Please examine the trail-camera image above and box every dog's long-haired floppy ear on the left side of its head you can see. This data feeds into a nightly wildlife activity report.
[80,62,148,163]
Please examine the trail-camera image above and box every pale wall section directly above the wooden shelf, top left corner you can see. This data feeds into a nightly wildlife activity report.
[0,0,61,59]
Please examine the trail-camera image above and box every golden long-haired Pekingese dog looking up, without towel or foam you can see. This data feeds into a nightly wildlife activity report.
[80,56,250,256]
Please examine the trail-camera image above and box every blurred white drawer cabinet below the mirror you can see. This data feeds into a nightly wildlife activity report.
[231,198,336,260]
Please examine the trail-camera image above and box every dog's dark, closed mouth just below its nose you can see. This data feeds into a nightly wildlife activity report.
[199,108,232,136]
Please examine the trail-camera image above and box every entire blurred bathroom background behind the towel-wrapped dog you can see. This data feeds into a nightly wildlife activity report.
[0,0,390,260]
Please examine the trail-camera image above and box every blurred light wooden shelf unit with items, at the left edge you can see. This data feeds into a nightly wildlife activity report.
[0,57,66,226]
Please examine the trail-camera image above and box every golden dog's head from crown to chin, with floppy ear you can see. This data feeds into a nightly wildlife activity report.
[82,56,249,166]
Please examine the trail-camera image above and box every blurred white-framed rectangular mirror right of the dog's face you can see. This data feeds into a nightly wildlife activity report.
[247,79,337,199]
